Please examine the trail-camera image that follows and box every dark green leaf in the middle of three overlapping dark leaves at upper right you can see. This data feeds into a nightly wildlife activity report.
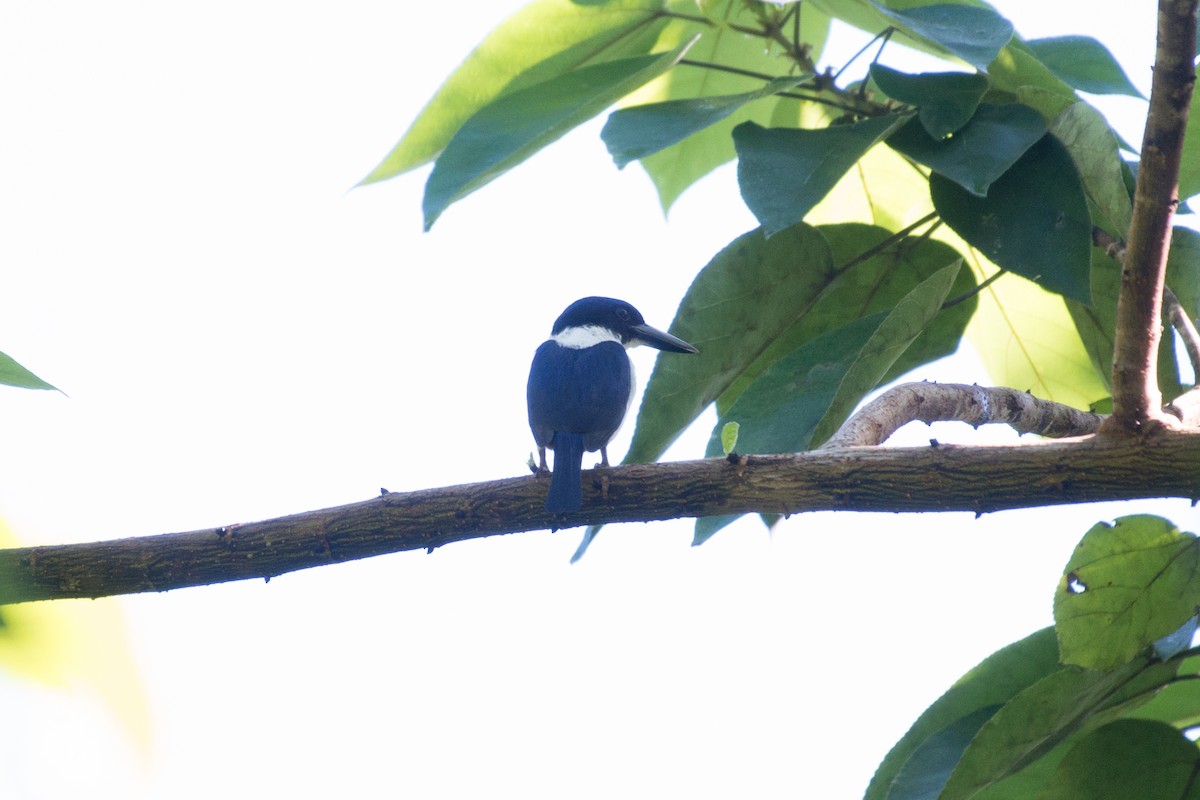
[888,103,1046,197]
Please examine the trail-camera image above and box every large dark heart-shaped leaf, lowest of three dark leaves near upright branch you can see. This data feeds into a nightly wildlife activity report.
[929,136,1092,303]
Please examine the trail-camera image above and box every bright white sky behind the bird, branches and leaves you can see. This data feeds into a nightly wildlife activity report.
[0,0,1200,799]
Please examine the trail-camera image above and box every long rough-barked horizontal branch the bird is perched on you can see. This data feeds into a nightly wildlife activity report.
[0,432,1200,603]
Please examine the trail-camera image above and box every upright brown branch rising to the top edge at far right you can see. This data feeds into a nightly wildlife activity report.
[1104,0,1196,431]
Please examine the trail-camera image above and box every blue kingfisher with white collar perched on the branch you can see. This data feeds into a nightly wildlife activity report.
[526,297,696,513]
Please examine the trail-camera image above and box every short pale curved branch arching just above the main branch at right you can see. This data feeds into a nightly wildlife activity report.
[821,383,1103,450]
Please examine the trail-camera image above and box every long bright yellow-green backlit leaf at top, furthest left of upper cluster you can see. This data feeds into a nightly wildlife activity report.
[360,0,666,185]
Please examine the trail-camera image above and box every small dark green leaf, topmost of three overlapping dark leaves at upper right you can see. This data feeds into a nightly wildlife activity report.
[871,62,988,139]
